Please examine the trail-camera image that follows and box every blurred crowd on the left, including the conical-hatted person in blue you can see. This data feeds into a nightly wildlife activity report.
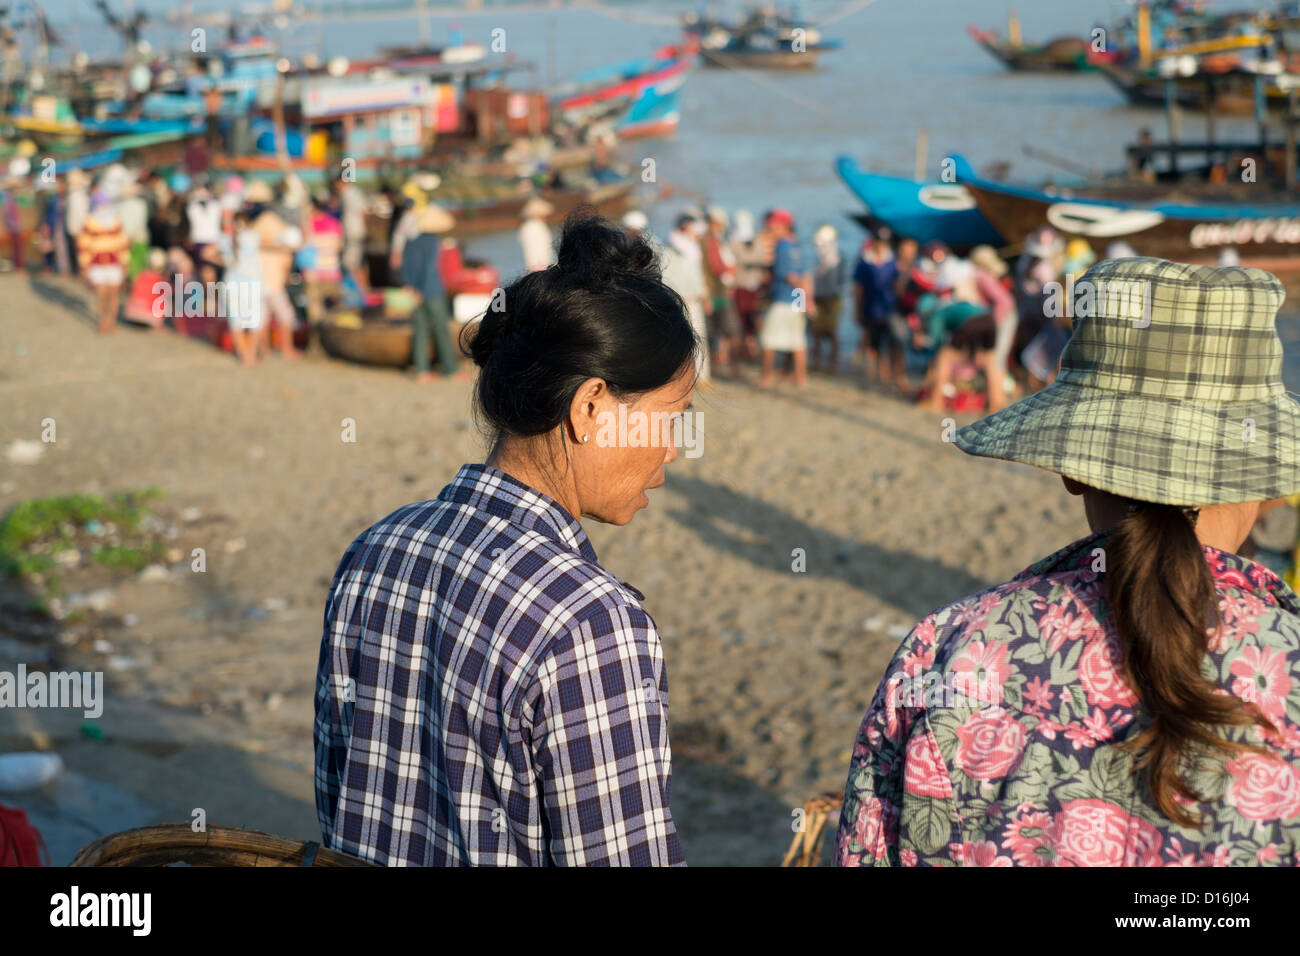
[0,157,496,380]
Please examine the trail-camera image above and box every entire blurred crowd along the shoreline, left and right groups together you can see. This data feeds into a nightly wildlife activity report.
[0,164,1185,411]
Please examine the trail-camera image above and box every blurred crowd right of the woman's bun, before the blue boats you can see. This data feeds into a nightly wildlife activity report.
[618,206,1159,411]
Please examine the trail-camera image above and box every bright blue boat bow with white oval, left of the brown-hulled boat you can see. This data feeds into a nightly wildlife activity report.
[835,156,1002,248]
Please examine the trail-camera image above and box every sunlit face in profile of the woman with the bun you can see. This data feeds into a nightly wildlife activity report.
[579,362,696,524]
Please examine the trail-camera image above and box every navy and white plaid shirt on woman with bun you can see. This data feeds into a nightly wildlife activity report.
[316,464,685,866]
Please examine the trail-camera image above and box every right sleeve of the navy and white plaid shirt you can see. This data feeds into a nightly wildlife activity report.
[528,606,685,866]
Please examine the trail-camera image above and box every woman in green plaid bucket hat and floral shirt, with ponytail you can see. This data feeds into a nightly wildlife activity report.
[837,259,1300,866]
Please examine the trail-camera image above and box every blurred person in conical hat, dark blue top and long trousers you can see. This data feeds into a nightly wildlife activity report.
[402,203,469,382]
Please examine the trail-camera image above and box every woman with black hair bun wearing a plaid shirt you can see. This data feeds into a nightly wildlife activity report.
[316,212,701,866]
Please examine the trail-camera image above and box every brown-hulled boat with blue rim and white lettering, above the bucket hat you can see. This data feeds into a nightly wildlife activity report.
[953,156,1300,267]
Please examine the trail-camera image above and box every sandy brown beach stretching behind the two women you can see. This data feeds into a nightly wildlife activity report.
[0,274,1086,865]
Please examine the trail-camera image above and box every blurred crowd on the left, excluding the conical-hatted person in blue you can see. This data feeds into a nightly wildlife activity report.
[16,164,367,363]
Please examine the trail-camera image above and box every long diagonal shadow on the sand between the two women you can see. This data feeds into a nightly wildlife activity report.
[668,472,993,618]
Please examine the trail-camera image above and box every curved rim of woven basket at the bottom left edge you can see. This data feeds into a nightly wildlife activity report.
[70,823,374,866]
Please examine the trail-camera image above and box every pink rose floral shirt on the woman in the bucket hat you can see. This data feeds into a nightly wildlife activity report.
[835,532,1300,866]
